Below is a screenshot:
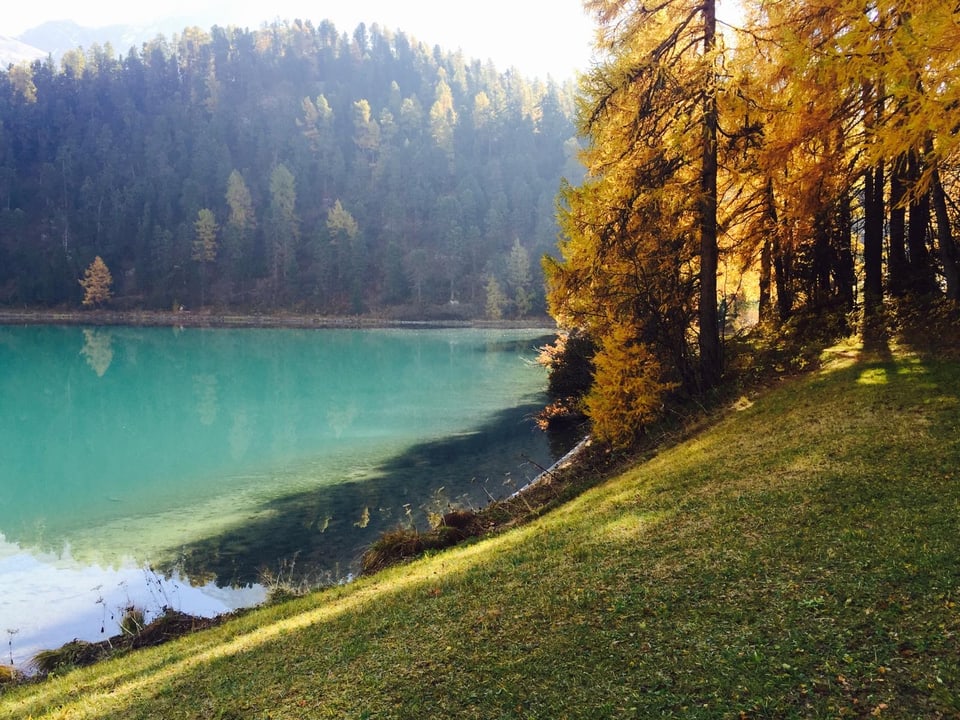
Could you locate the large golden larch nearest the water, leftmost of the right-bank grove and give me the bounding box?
[545,0,722,444]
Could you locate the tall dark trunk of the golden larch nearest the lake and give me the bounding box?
[700,0,722,389]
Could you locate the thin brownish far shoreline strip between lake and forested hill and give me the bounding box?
[0,308,556,331]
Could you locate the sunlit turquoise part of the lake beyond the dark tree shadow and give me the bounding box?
[0,328,556,562]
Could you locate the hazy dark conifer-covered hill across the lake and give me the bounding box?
[0,21,582,317]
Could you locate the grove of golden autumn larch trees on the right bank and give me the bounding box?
[546,0,960,445]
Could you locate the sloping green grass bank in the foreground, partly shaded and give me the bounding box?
[0,340,960,720]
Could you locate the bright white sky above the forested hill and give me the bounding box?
[0,0,593,81]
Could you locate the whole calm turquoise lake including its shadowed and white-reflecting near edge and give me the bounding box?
[0,326,569,665]
